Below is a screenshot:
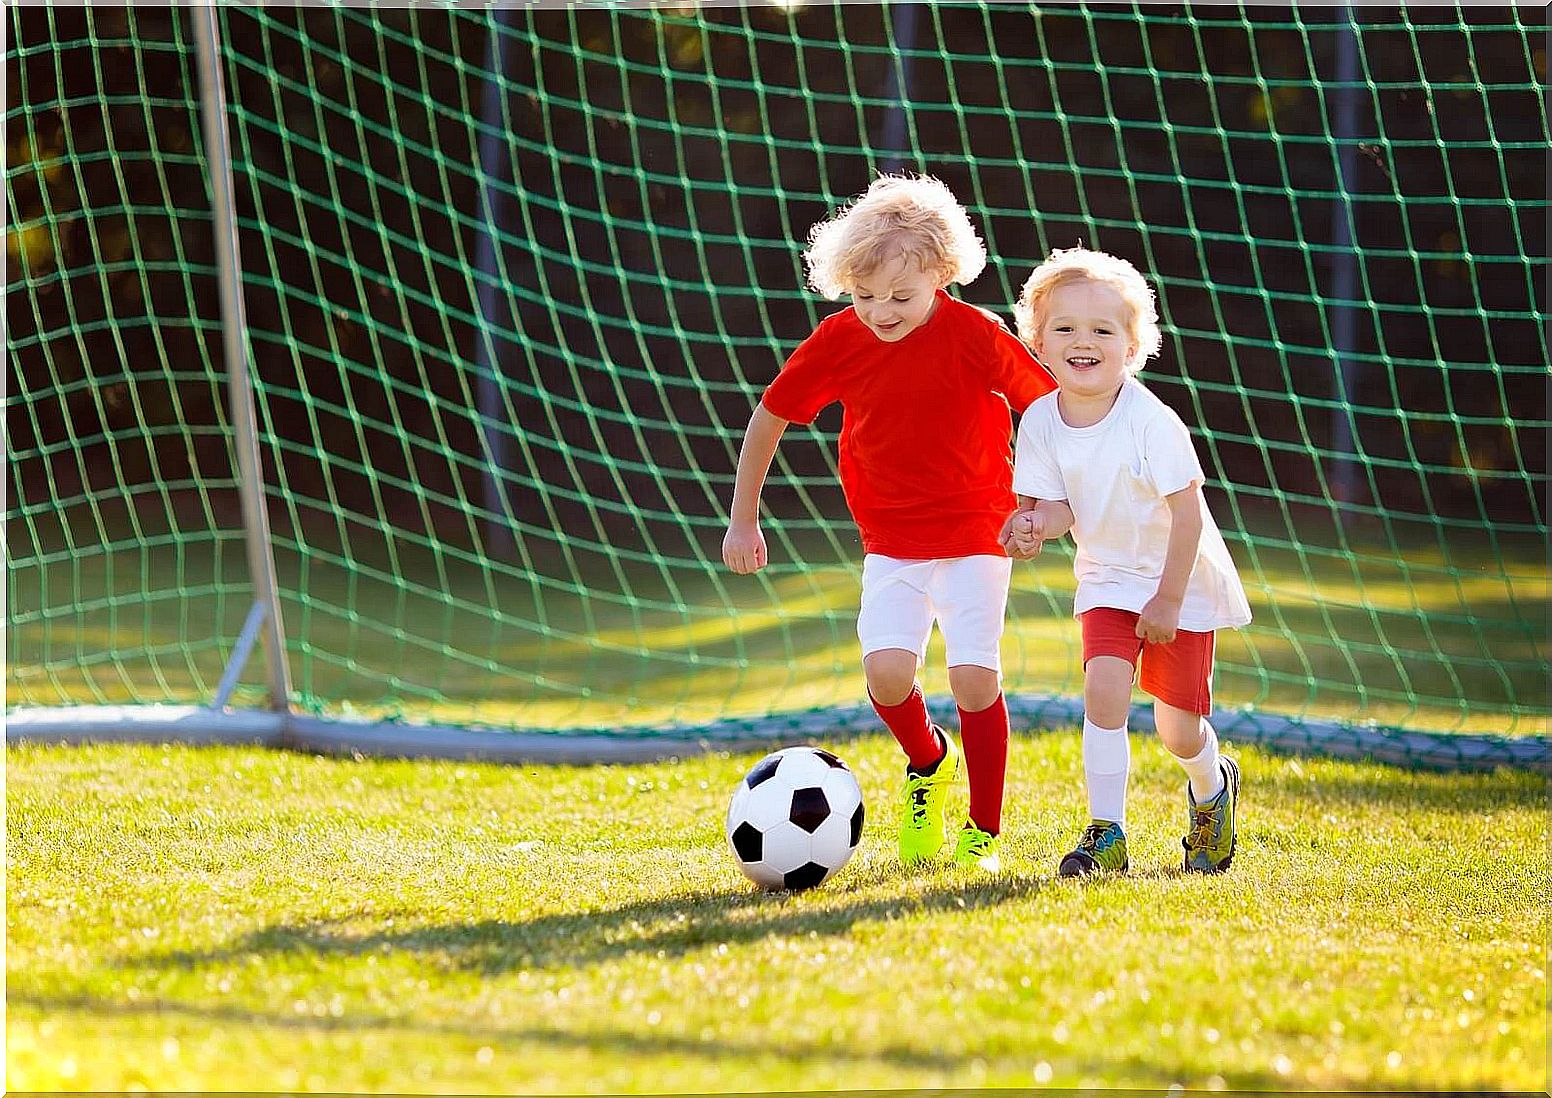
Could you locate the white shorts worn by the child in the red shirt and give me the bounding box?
[857,553,1013,672]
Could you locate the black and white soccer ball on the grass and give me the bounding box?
[728,747,863,891]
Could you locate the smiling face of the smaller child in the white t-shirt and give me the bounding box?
[1034,278,1138,399]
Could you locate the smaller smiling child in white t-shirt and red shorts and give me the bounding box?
[1007,247,1251,876]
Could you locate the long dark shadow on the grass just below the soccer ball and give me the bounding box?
[146,865,1051,975]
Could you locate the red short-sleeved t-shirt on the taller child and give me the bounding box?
[760,290,1057,561]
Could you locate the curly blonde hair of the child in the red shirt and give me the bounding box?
[802,175,986,301]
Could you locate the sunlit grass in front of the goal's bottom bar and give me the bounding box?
[6,733,1549,1093]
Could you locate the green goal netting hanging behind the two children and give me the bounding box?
[6,5,1549,748]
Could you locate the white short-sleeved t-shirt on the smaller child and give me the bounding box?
[1013,379,1251,632]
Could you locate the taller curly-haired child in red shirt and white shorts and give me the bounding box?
[722,175,1055,873]
